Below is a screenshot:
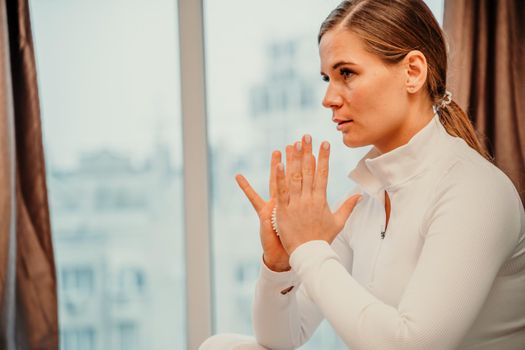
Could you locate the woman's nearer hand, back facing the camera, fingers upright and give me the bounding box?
[274,135,361,255]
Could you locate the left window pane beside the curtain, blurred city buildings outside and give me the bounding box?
[30,0,186,350]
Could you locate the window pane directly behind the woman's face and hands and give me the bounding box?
[204,0,443,349]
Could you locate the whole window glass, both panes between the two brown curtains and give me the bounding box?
[30,0,443,350]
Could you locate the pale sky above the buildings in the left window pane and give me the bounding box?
[31,0,180,166]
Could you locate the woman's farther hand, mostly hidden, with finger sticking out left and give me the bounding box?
[235,146,291,272]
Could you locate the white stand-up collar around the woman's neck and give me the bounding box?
[349,114,452,201]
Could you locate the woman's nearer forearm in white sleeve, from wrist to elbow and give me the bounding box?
[291,241,451,350]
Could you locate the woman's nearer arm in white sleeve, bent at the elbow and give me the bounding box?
[290,165,521,350]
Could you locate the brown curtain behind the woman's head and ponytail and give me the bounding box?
[444,0,525,203]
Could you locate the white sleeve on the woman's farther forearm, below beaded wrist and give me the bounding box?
[253,226,352,349]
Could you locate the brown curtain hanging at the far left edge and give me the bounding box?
[0,0,58,350]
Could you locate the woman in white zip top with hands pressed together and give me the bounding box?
[202,0,525,350]
